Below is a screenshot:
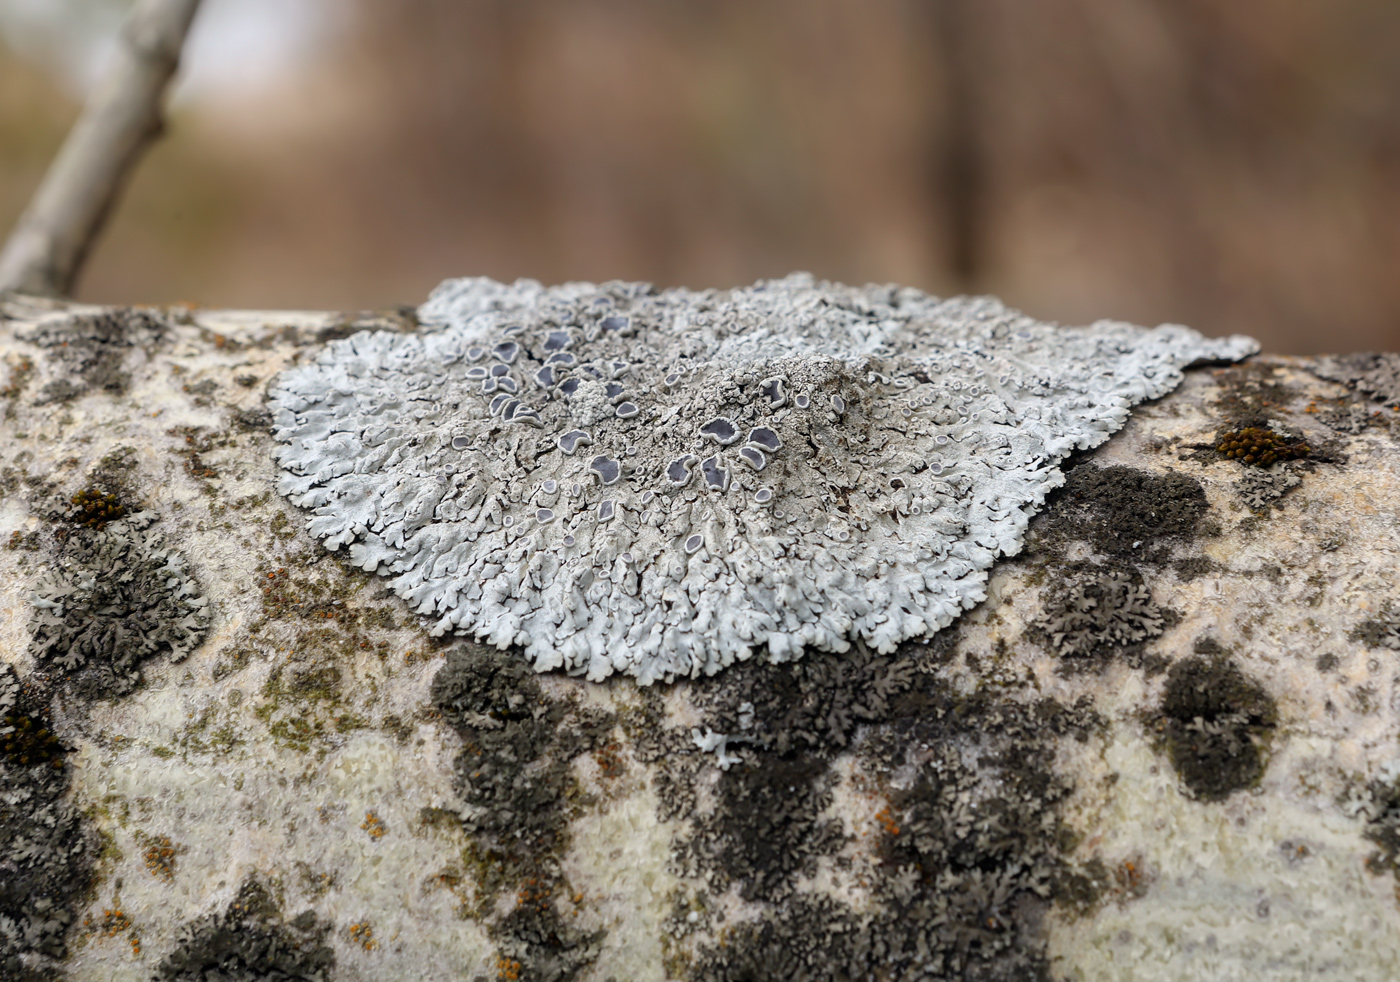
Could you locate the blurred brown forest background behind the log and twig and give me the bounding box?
[0,0,1400,353]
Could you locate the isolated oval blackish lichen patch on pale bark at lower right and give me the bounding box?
[1158,639,1278,801]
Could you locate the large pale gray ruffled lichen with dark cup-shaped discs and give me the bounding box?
[272,276,1257,684]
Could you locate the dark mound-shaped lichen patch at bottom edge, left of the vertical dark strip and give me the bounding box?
[153,880,335,982]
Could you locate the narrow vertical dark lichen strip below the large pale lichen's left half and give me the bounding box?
[433,643,615,982]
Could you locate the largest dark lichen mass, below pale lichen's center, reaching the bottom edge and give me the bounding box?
[658,637,1098,982]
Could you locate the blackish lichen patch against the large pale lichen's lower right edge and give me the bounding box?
[1030,464,1210,563]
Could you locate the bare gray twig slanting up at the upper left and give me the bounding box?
[0,0,199,296]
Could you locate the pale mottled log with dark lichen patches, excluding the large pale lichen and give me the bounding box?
[0,287,1400,982]
